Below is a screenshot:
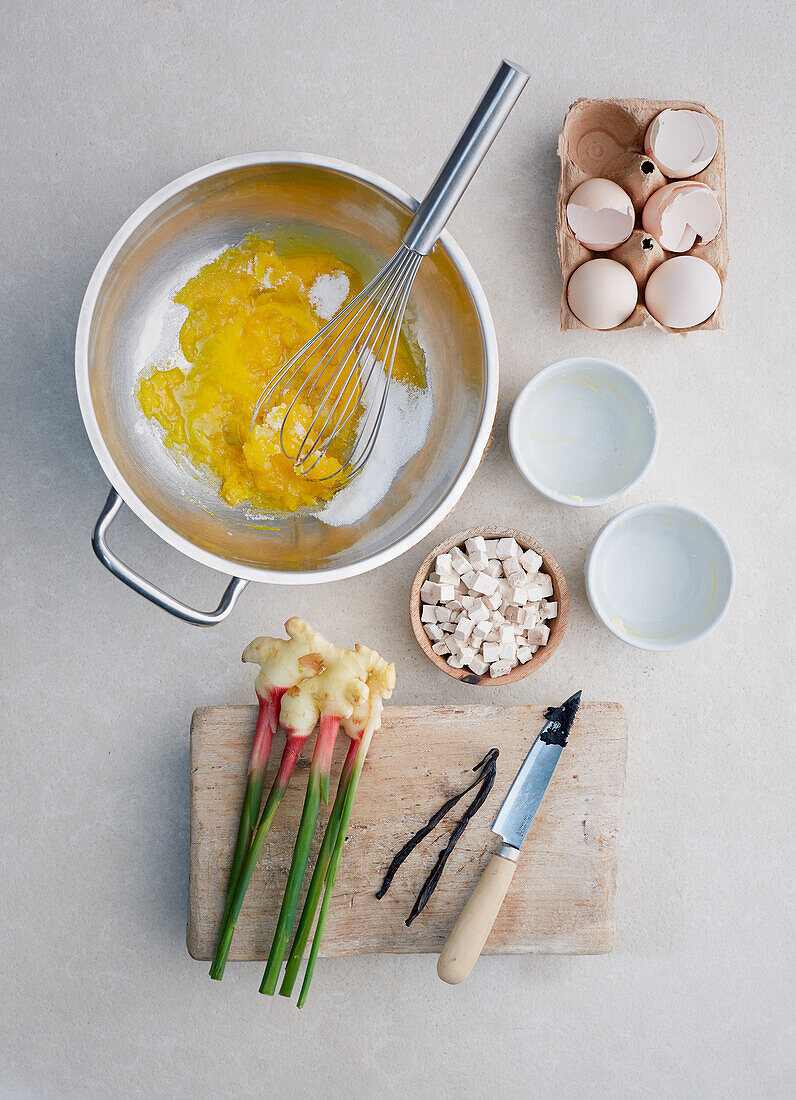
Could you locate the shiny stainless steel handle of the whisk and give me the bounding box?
[401,61,529,256]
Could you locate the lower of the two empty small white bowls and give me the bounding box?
[586,502,734,652]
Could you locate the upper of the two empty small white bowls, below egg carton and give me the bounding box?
[509,358,659,508]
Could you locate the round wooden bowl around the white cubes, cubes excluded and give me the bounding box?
[409,527,570,688]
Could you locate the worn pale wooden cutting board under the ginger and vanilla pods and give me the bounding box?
[188,703,627,959]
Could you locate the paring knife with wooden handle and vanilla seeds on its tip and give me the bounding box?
[436,691,581,986]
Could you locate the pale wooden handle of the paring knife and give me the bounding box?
[436,855,517,986]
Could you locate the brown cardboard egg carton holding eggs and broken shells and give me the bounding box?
[556,99,729,336]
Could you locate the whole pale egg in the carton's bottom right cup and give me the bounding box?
[644,256,721,329]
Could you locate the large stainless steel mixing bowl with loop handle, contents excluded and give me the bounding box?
[75,153,498,626]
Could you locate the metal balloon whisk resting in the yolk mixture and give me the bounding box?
[251,61,529,481]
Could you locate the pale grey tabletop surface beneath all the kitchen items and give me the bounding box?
[0,0,794,1100]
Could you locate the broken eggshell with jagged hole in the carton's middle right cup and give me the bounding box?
[641,180,721,252]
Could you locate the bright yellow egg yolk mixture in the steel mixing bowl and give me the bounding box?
[137,233,425,512]
